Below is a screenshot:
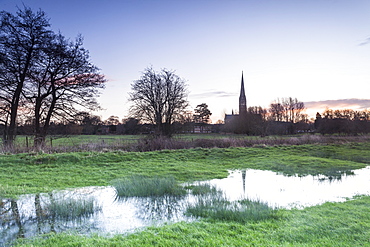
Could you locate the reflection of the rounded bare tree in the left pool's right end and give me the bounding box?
[136,195,186,220]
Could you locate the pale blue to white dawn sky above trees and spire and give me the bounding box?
[0,0,370,123]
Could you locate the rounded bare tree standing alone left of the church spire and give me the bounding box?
[130,68,188,136]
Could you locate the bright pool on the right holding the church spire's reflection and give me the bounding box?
[210,167,370,208]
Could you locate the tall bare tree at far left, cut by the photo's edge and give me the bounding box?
[0,7,52,147]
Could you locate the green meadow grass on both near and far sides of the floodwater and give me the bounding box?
[0,135,370,246]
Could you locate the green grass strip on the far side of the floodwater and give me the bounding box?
[0,142,370,197]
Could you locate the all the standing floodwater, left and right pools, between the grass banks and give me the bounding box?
[0,166,370,246]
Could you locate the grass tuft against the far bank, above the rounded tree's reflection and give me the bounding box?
[112,175,186,198]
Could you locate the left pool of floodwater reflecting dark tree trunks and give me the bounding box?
[0,187,193,246]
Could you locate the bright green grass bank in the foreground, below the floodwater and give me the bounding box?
[18,197,370,246]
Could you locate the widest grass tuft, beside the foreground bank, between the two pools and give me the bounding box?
[186,188,276,223]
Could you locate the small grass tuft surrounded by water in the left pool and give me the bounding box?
[47,197,101,220]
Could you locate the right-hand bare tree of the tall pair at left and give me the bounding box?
[23,34,105,147]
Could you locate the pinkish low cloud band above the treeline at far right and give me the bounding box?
[304,99,370,110]
